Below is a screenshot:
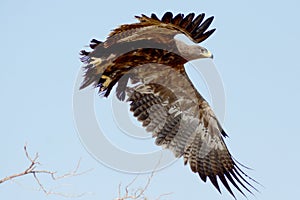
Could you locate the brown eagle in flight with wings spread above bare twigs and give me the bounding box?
[80,12,257,198]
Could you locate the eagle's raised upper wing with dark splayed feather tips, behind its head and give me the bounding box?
[105,12,215,46]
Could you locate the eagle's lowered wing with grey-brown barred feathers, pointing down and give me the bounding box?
[127,64,256,196]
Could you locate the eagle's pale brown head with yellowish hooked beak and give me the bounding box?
[175,39,213,61]
